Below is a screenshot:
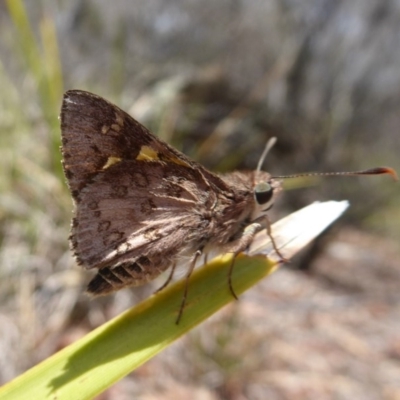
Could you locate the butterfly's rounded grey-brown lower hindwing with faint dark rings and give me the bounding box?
[72,160,214,268]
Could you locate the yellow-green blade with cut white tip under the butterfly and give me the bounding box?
[0,202,347,400]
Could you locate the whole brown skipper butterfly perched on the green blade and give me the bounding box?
[61,90,395,321]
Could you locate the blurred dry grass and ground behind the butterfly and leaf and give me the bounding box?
[0,0,400,400]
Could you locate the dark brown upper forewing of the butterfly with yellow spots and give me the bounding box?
[60,90,198,200]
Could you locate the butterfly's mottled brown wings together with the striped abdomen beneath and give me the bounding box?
[61,90,233,294]
